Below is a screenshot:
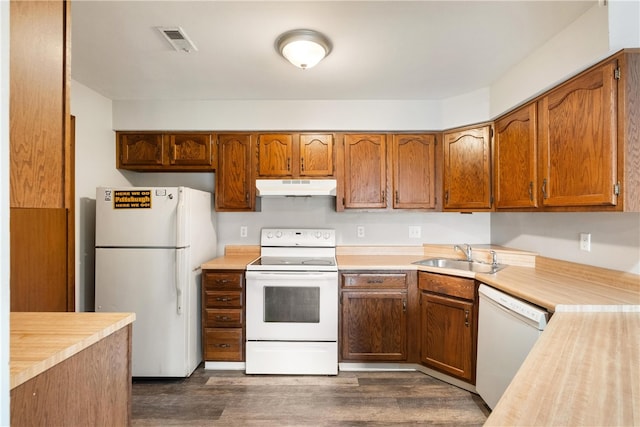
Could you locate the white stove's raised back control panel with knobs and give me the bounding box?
[260,228,336,247]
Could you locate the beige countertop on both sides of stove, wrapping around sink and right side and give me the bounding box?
[202,245,640,425]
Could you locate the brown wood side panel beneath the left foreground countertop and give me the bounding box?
[10,325,131,426]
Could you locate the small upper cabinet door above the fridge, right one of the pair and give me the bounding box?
[168,133,213,167]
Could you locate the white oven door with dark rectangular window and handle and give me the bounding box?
[246,271,338,341]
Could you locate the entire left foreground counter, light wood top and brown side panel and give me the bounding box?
[9,312,135,426]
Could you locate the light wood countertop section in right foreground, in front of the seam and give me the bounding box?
[485,312,640,426]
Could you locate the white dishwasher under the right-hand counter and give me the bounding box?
[476,285,548,409]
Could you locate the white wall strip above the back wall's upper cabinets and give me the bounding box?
[113,100,442,131]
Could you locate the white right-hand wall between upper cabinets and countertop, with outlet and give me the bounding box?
[491,212,640,274]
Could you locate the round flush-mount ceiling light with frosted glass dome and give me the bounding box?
[276,30,331,70]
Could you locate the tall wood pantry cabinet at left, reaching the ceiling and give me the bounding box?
[9,0,75,311]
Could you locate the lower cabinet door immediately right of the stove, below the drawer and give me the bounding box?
[341,291,407,361]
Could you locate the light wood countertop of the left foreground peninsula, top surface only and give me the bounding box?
[9,312,136,389]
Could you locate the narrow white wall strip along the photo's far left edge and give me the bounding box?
[0,1,10,426]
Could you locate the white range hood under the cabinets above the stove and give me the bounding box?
[256,179,336,197]
